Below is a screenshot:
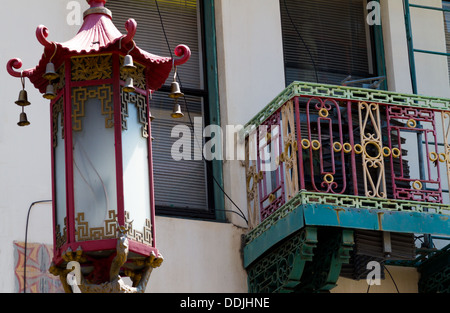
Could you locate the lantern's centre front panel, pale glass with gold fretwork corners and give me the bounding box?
[72,85,117,232]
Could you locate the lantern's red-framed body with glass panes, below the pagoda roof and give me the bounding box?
[51,53,158,283]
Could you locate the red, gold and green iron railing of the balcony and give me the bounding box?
[242,82,450,234]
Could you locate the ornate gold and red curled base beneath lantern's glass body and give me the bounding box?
[49,234,164,293]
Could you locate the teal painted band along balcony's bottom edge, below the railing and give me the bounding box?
[244,197,450,267]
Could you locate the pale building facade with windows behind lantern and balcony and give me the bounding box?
[0,0,450,293]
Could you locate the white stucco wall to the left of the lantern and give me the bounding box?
[0,0,87,292]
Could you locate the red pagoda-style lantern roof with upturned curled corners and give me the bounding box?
[7,0,191,93]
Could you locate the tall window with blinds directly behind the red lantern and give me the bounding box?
[107,0,219,218]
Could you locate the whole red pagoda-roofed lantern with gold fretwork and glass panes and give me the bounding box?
[7,0,190,292]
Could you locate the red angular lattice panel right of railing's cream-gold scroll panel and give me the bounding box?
[386,106,446,203]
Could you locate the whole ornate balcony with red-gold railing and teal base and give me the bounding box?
[242,82,450,292]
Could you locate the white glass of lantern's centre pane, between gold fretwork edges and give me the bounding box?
[73,87,117,228]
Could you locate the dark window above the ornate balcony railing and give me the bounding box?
[280,0,384,87]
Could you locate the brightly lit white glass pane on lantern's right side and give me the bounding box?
[122,94,151,236]
